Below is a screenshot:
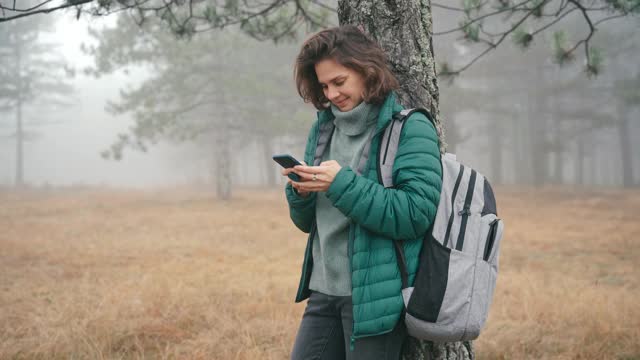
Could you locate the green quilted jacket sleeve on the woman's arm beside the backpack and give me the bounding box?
[326,113,442,240]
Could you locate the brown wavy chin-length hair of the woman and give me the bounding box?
[293,25,399,110]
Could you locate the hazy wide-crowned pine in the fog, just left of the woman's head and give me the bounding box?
[86,16,306,199]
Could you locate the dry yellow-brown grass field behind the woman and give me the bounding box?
[0,188,640,360]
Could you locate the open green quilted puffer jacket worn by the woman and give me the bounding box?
[286,93,442,344]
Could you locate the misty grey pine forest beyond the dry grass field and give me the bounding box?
[0,2,640,196]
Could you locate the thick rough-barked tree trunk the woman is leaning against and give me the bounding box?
[338,0,474,360]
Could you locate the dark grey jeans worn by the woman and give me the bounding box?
[291,291,407,360]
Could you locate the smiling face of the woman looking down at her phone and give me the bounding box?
[315,58,365,112]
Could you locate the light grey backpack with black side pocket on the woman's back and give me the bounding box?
[378,109,504,342]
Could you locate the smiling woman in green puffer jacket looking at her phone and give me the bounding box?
[282,26,441,360]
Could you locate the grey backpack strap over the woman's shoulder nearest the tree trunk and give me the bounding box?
[378,108,436,188]
